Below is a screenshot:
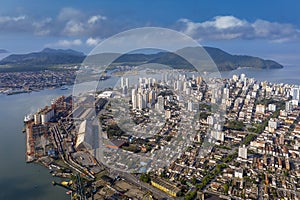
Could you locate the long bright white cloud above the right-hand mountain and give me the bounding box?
[178,16,300,42]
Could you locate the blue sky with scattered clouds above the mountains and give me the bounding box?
[0,0,300,65]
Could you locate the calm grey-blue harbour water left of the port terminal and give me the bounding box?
[0,90,71,200]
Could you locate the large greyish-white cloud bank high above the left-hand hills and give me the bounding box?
[0,7,110,38]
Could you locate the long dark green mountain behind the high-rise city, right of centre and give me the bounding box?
[110,47,283,71]
